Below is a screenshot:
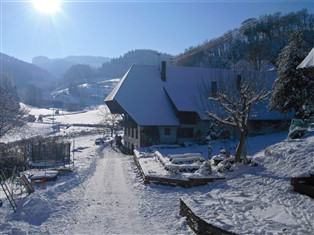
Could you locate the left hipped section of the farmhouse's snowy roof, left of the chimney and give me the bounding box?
[105,65,180,126]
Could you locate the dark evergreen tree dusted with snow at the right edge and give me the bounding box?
[269,33,314,118]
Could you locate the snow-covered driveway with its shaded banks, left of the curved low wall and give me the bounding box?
[0,139,194,235]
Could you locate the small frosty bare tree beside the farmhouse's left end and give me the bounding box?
[99,106,122,137]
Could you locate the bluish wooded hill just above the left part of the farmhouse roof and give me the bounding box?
[99,49,173,78]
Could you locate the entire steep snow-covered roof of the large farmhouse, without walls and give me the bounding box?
[105,65,281,126]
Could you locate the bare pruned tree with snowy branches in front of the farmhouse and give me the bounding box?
[206,71,270,162]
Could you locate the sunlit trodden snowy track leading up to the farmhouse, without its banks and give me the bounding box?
[73,148,160,234]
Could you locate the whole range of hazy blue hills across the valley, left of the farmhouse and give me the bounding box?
[1,49,172,108]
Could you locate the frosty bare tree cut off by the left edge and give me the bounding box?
[0,74,28,139]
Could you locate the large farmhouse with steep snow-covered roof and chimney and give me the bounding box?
[105,62,282,150]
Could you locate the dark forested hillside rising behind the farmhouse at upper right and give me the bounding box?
[173,10,314,70]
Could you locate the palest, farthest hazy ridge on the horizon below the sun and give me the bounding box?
[32,56,111,77]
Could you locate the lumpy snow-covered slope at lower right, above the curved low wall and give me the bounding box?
[183,132,314,234]
